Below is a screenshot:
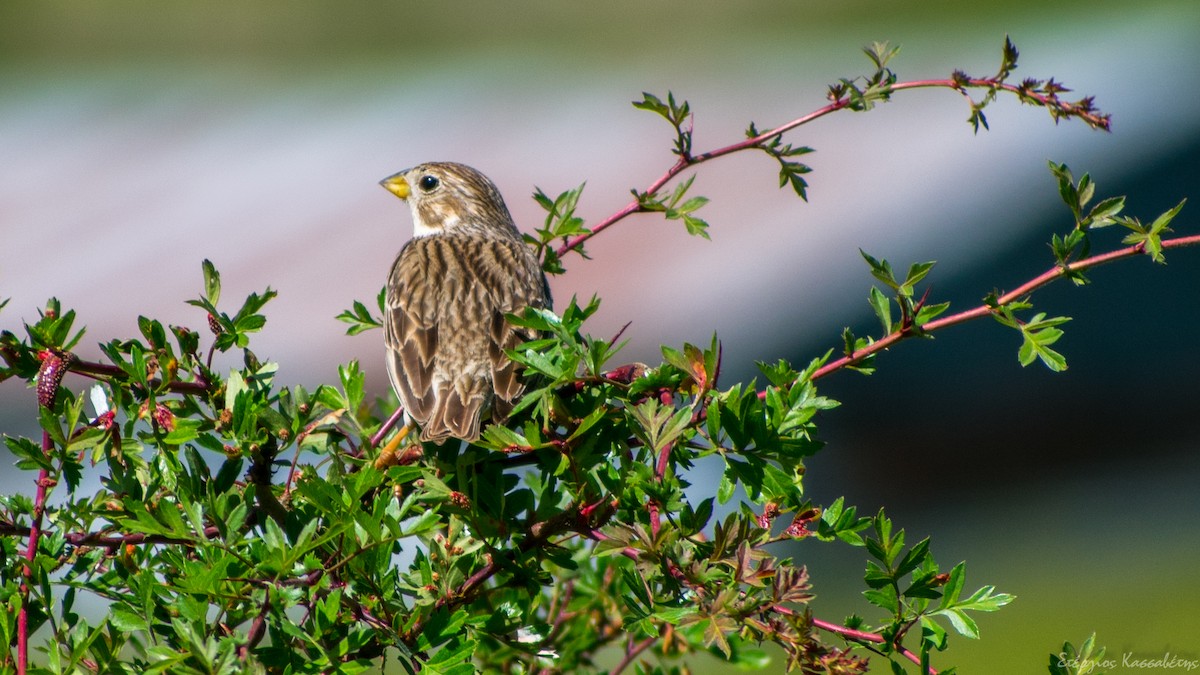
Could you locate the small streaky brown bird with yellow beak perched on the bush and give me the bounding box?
[379,162,551,443]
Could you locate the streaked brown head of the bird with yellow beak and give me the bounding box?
[379,162,516,237]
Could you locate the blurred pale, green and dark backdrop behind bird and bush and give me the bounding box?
[0,0,1200,673]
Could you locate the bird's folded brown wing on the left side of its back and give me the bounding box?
[384,238,439,425]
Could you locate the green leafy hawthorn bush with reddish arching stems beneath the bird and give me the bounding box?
[0,42,1200,674]
